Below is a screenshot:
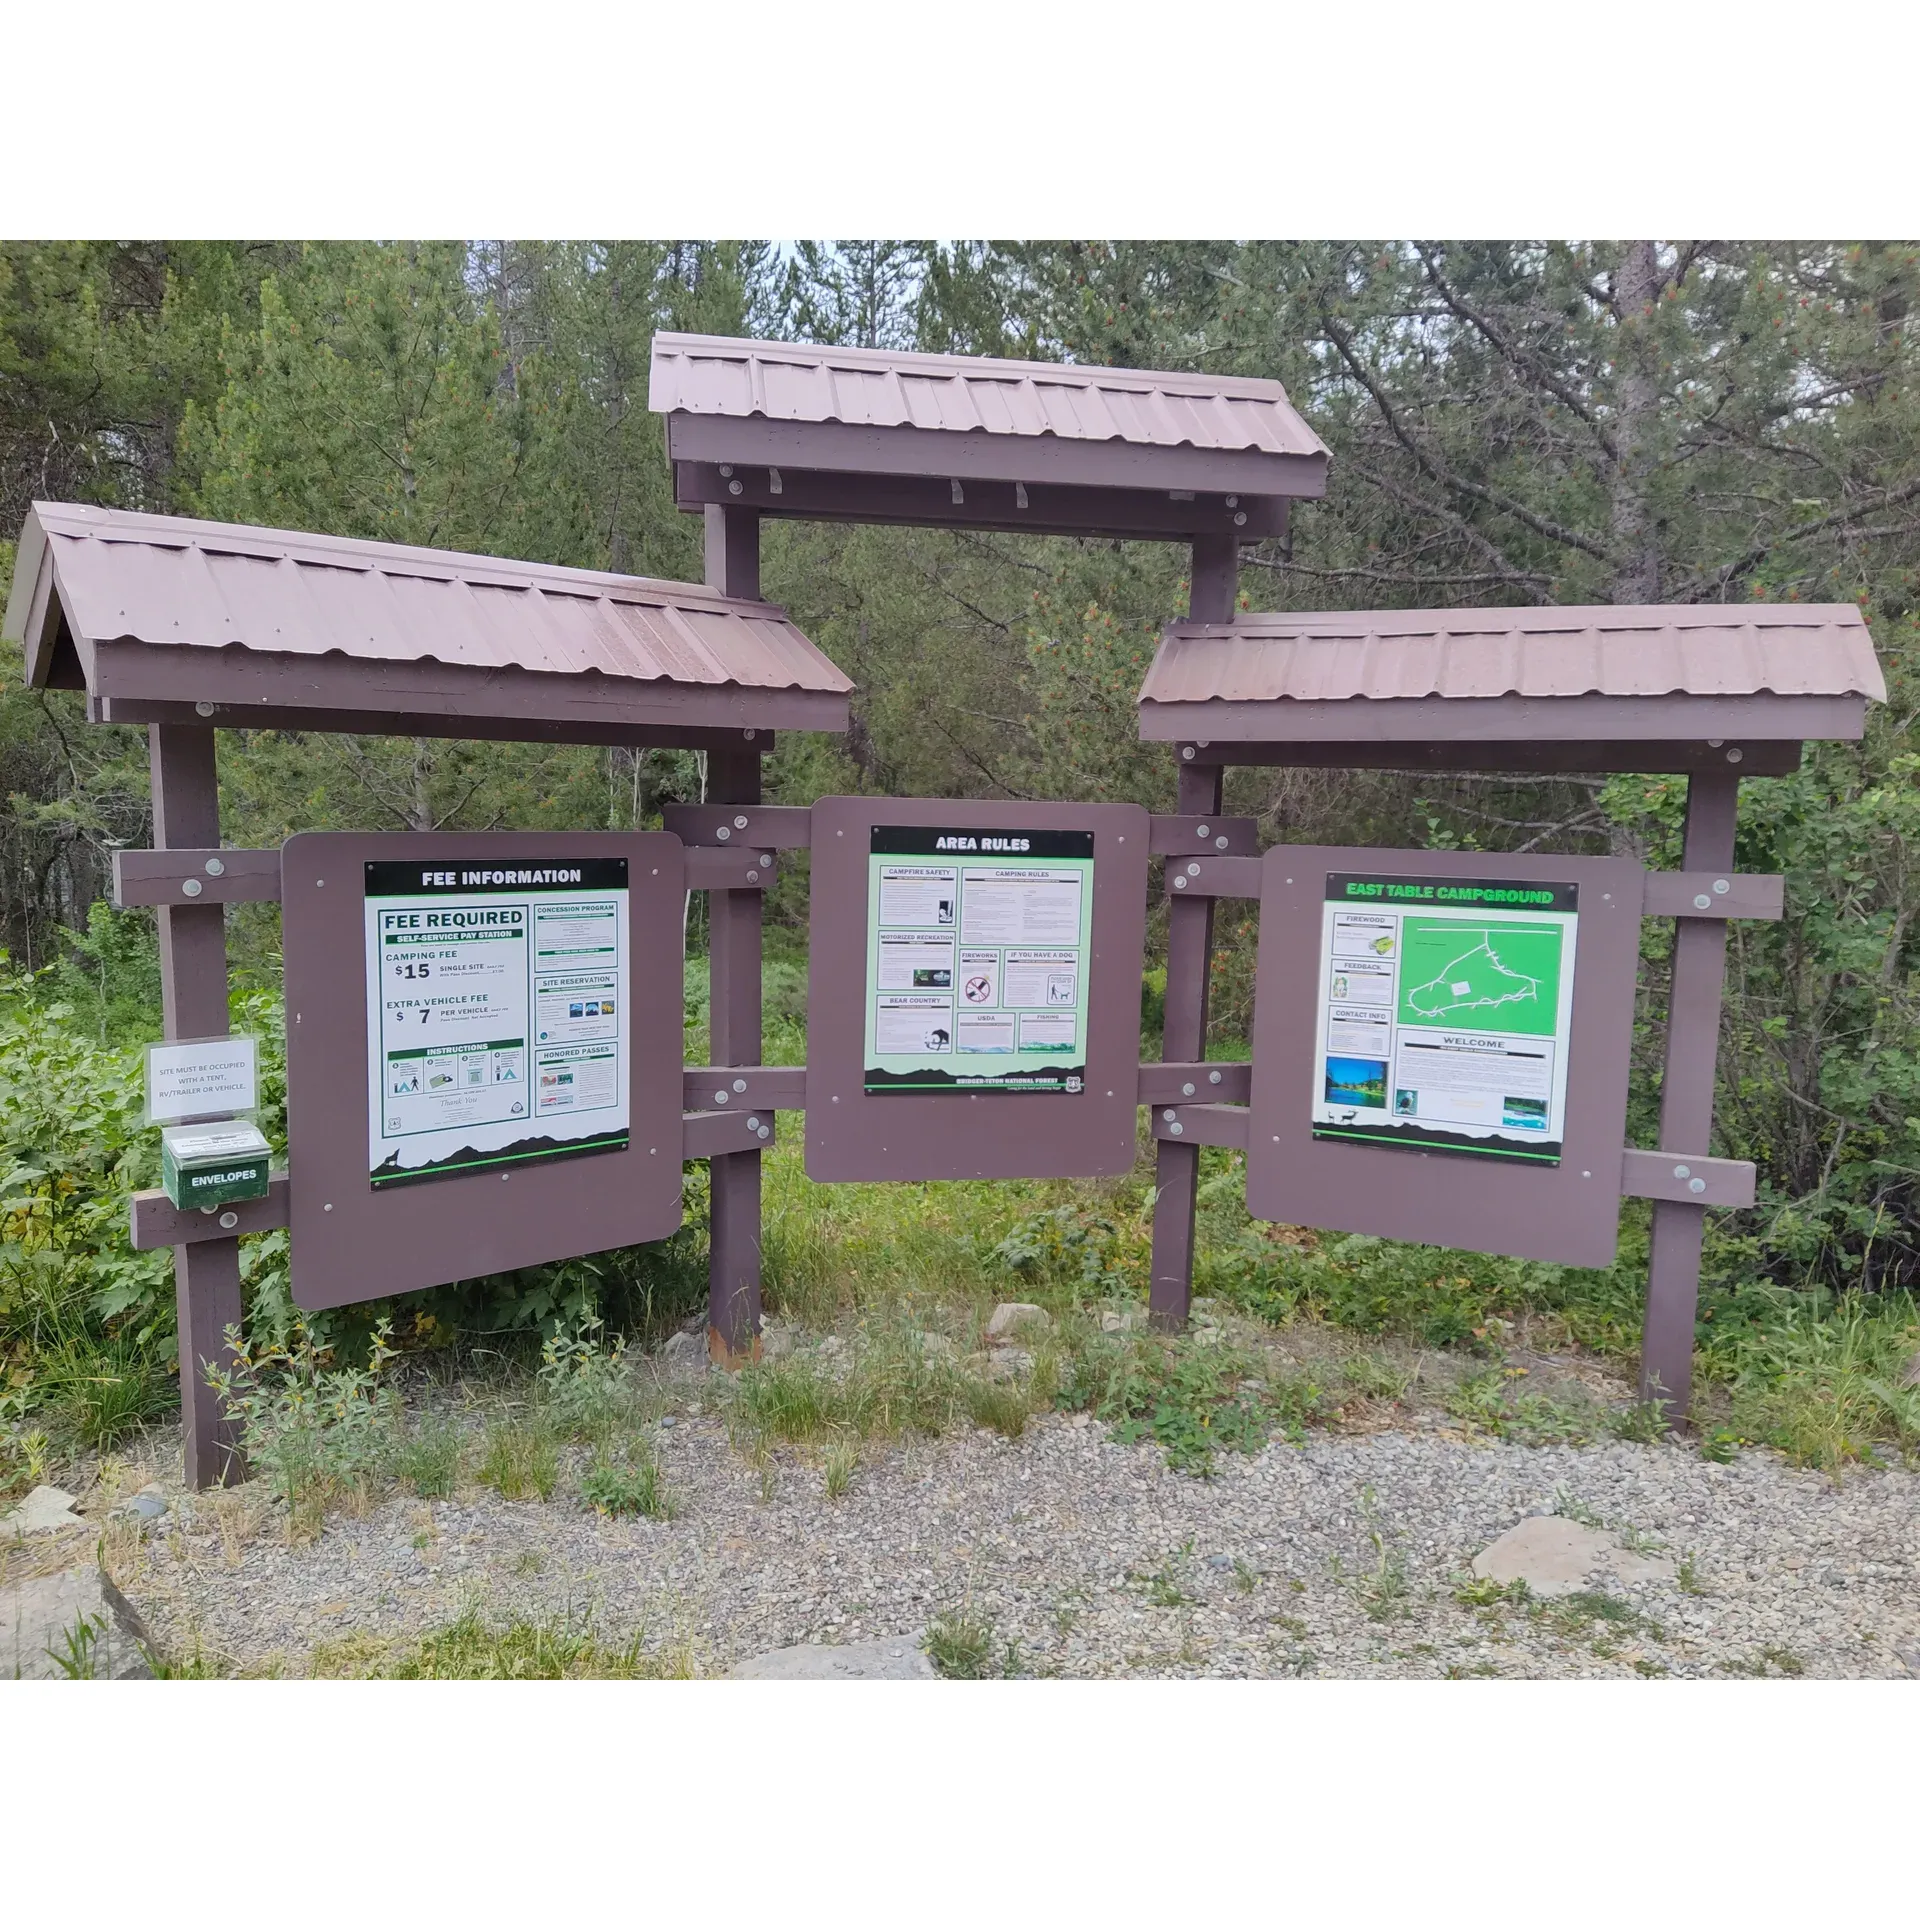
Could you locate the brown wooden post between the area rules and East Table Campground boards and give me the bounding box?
[1146,534,1240,1329]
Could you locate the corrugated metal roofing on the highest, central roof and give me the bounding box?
[647,334,1327,457]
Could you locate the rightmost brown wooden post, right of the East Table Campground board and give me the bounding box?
[1640,770,1740,1423]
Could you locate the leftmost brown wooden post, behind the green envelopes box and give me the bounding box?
[146,726,244,1486]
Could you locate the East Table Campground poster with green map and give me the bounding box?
[1313,874,1580,1167]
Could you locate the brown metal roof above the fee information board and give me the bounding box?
[6,503,852,728]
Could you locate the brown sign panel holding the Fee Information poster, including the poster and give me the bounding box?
[282,833,685,1308]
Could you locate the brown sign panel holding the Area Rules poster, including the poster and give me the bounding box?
[806,799,1148,1181]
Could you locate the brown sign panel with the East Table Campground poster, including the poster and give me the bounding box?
[1246,847,1644,1267]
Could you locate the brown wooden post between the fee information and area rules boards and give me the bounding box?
[707,507,762,1369]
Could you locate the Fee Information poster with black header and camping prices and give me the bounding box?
[367,858,630,1188]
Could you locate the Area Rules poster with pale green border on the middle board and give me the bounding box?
[864,828,1092,1094]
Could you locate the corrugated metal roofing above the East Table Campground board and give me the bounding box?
[1140,603,1887,707]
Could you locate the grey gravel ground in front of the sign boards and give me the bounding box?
[109,1413,1920,1678]
